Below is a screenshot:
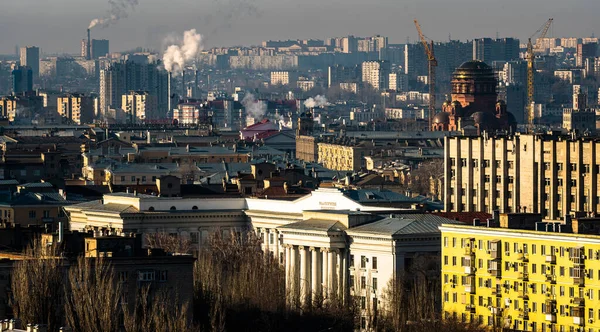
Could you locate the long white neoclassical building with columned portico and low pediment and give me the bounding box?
[65,188,457,328]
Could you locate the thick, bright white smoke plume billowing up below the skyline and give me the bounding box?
[163,29,202,74]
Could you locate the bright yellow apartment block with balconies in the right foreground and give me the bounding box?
[440,213,600,331]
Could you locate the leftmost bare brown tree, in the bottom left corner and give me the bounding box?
[11,239,65,331]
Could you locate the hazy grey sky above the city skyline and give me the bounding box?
[0,0,600,54]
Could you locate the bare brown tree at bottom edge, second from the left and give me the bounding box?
[65,256,121,332]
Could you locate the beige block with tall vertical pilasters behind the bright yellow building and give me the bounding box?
[443,133,600,220]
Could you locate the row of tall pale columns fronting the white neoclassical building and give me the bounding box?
[284,244,348,307]
